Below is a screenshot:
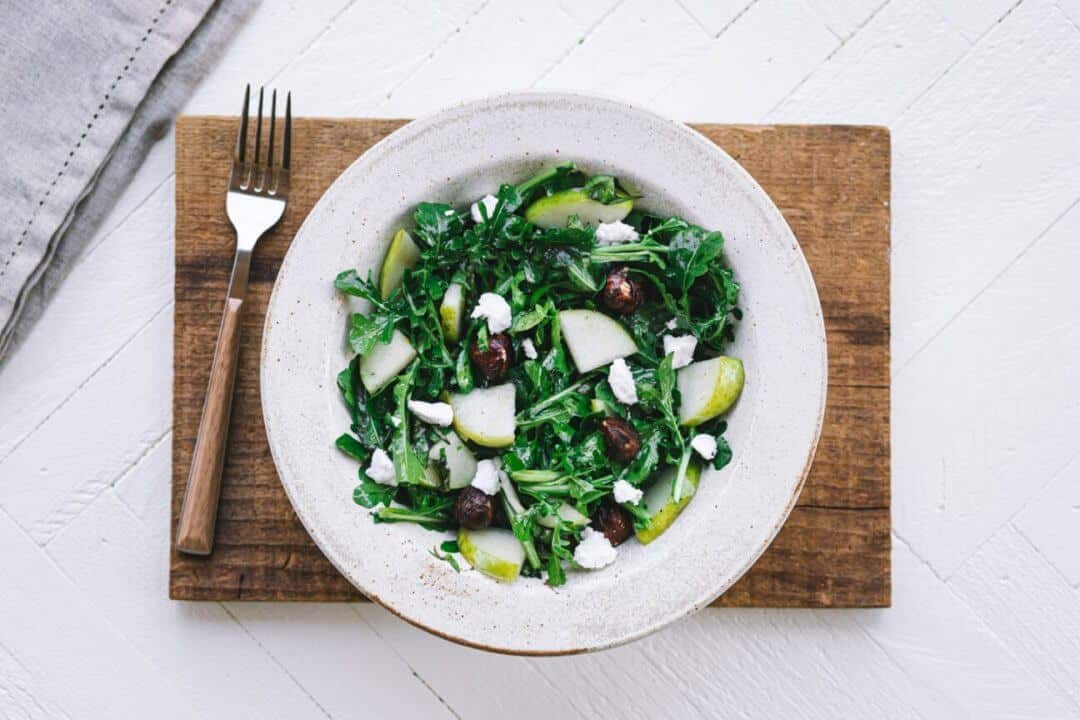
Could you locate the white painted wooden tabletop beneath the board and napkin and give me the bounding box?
[0,0,1080,720]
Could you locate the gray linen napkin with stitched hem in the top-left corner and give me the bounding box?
[0,0,257,361]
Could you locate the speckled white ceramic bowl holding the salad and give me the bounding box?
[261,93,826,654]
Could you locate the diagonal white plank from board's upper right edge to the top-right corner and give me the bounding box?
[893,0,1080,367]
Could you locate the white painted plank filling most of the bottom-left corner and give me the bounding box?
[0,512,191,720]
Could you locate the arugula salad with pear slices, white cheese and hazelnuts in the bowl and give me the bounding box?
[334,163,744,586]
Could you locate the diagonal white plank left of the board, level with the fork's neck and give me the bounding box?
[0,181,174,462]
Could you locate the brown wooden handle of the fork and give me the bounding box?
[176,297,244,555]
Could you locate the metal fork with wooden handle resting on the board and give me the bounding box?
[176,85,293,555]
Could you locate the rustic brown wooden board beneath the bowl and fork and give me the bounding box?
[168,117,891,608]
